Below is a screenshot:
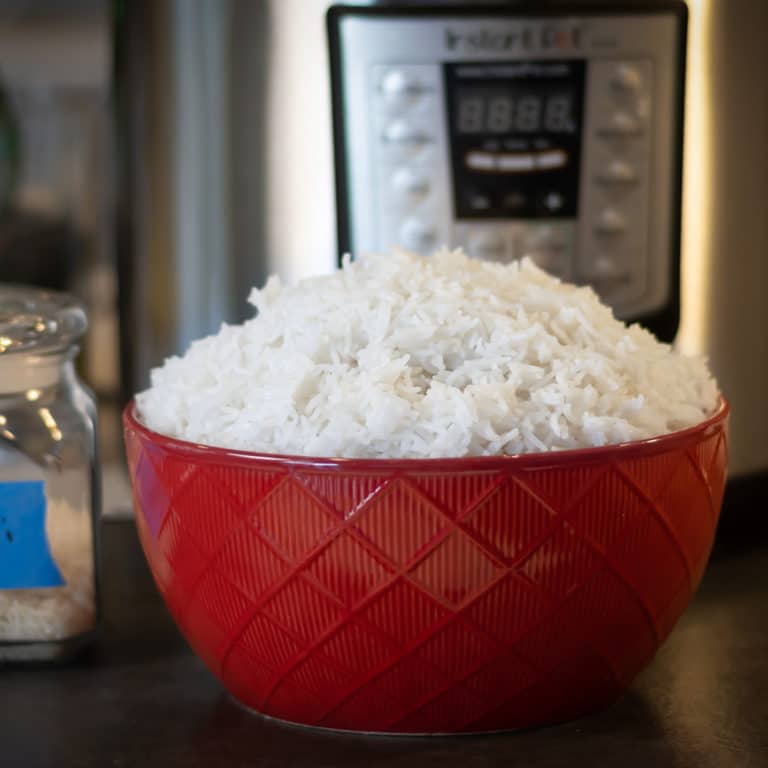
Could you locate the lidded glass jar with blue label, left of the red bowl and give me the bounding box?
[0,285,100,661]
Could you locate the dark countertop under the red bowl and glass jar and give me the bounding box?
[0,522,768,768]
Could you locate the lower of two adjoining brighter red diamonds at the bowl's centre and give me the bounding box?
[409,530,501,606]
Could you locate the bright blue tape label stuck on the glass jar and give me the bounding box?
[0,480,64,589]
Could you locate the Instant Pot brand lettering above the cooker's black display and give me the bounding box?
[445,24,582,52]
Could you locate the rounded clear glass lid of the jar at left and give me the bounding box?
[0,285,88,360]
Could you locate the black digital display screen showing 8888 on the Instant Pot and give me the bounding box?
[443,60,585,219]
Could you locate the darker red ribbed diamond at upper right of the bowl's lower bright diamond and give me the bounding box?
[465,479,556,561]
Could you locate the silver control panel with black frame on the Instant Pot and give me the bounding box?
[328,2,686,341]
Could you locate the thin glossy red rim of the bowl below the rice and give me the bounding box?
[123,395,730,473]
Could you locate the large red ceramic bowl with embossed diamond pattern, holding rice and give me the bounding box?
[124,403,728,733]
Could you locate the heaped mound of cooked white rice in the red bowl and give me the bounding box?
[137,250,718,457]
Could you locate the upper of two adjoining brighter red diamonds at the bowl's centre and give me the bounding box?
[355,482,448,566]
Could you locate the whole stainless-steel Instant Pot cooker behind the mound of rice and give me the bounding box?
[116,0,768,498]
